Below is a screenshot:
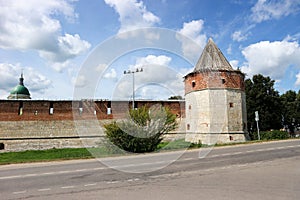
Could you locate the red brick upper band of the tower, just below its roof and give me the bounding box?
[185,71,245,94]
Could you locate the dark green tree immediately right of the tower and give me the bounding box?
[245,74,282,132]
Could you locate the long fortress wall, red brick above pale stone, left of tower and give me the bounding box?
[0,99,185,151]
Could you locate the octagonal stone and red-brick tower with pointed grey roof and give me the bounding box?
[184,38,248,144]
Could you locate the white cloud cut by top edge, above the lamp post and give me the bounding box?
[104,0,160,33]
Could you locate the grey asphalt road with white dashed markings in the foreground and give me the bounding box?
[0,140,300,200]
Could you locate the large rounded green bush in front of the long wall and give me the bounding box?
[104,106,177,153]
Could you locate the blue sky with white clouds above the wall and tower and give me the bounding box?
[0,0,300,100]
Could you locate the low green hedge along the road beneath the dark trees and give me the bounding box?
[250,130,289,140]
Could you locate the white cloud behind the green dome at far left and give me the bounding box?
[0,63,52,98]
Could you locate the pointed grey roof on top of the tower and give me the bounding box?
[194,38,234,72]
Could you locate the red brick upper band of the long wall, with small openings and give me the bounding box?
[0,100,185,121]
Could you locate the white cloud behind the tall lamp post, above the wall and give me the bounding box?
[113,55,184,100]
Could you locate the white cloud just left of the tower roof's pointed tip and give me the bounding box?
[176,19,207,60]
